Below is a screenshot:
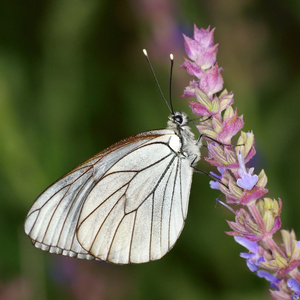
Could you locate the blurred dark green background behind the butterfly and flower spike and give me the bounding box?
[0,0,300,300]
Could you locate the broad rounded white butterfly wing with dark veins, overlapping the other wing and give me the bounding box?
[77,133,192,264]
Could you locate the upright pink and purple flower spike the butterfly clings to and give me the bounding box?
[182,25,300,300]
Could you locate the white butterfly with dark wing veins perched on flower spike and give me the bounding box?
[24,51,201,264]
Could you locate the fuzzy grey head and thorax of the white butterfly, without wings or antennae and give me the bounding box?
[168,112,201,165]
